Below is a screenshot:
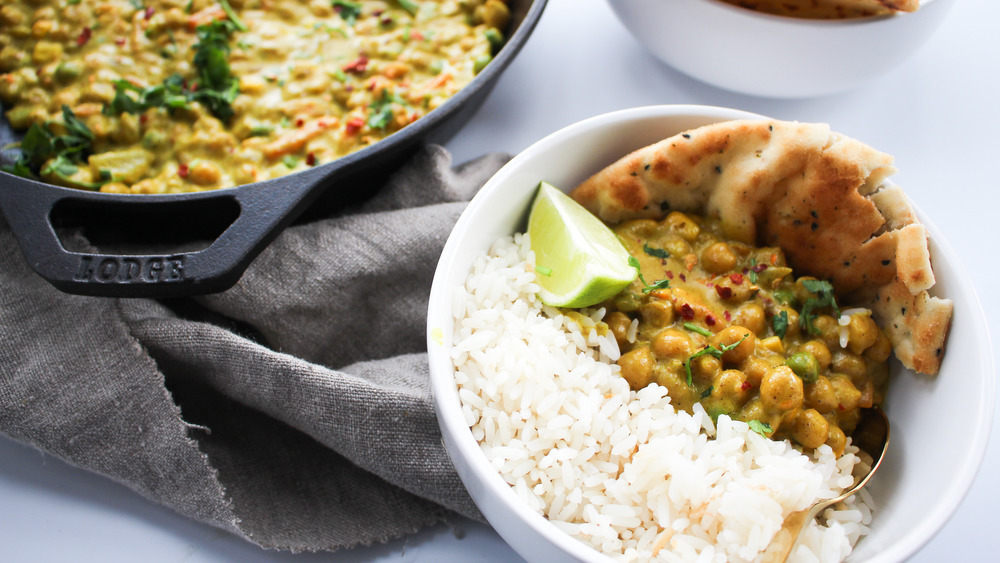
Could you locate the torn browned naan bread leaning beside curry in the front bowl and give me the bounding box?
[571,120,952,374]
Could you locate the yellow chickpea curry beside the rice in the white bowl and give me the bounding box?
[604,212,891,455]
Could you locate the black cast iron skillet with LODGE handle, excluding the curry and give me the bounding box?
[0,0,547,297]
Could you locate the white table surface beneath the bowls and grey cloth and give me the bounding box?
[0,0,1000,562]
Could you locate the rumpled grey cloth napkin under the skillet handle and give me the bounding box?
[0,146,508,552]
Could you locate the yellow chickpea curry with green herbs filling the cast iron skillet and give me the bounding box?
[0,0,510,193]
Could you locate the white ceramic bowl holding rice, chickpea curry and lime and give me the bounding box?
[427,106,994,563]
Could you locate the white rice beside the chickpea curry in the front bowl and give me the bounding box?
[452,231,872,562]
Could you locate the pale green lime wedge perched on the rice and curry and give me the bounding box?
[528,182,638,308]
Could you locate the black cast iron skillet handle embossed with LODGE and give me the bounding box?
[0,168,330,298]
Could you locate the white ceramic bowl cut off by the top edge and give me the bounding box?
[608,0,953,98]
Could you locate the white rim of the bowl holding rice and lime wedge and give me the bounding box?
[427,104,995,562]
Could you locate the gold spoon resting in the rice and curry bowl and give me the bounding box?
[763,407,889,563]
